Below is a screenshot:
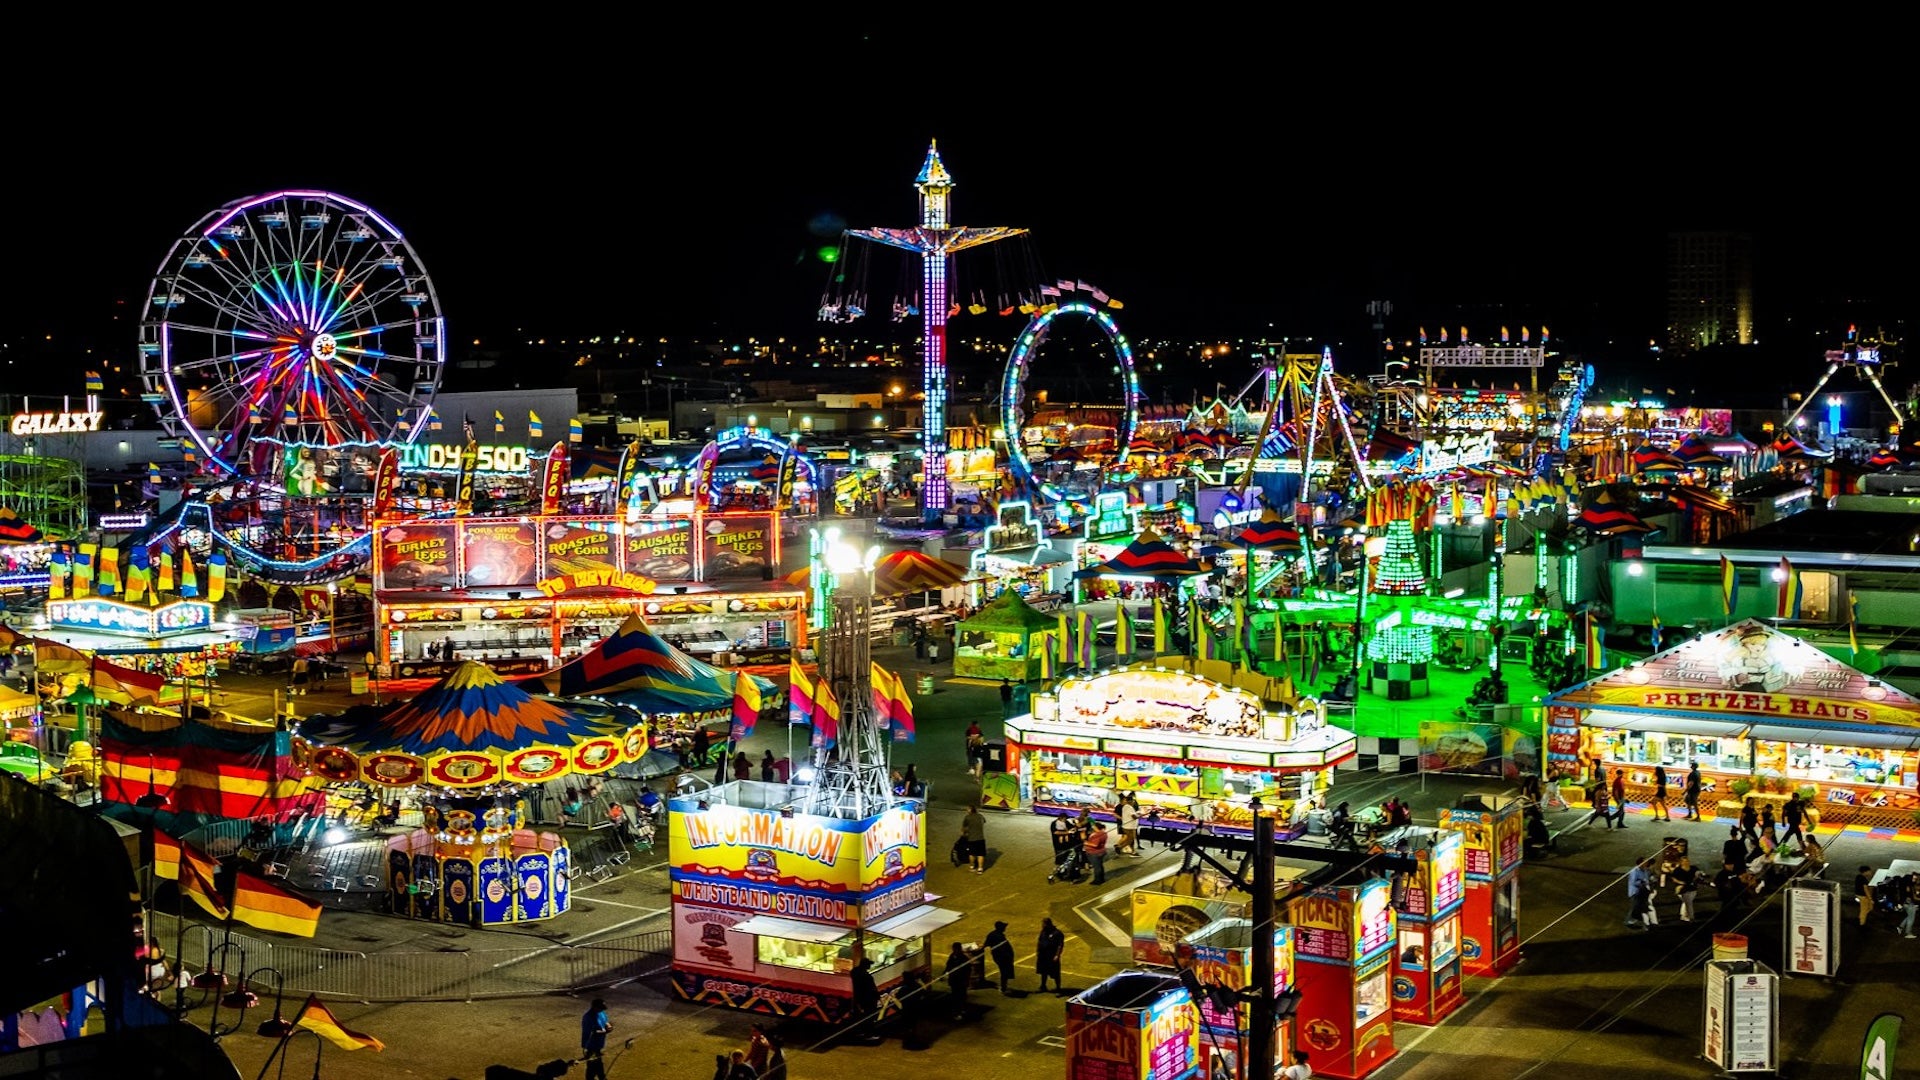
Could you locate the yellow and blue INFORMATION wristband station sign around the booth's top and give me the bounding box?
[668,799,927,926]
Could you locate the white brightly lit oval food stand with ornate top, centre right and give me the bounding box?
[1002,663,1356,826]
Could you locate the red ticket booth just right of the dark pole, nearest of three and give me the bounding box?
[1281,878,1396,1080]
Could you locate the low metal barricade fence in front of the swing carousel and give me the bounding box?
[154,913,672,1007]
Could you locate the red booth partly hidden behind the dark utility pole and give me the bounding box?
[1175,919,1296,1080]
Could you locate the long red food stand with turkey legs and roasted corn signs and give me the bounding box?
[372,511,806,678]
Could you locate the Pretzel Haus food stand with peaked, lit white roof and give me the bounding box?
[1548,619,1920,828]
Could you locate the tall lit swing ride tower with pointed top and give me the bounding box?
[847,142,1025,521]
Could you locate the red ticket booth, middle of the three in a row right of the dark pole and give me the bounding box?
[1394,826,1467,1024]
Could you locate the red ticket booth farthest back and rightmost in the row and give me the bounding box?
[1440,796,1524,974]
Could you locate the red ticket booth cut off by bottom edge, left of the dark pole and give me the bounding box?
[1066,970,1200,1080]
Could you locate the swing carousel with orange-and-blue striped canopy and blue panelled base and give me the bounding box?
[296,661,649,926]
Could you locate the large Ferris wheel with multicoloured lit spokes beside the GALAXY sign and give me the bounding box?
[140,190,445,475]
